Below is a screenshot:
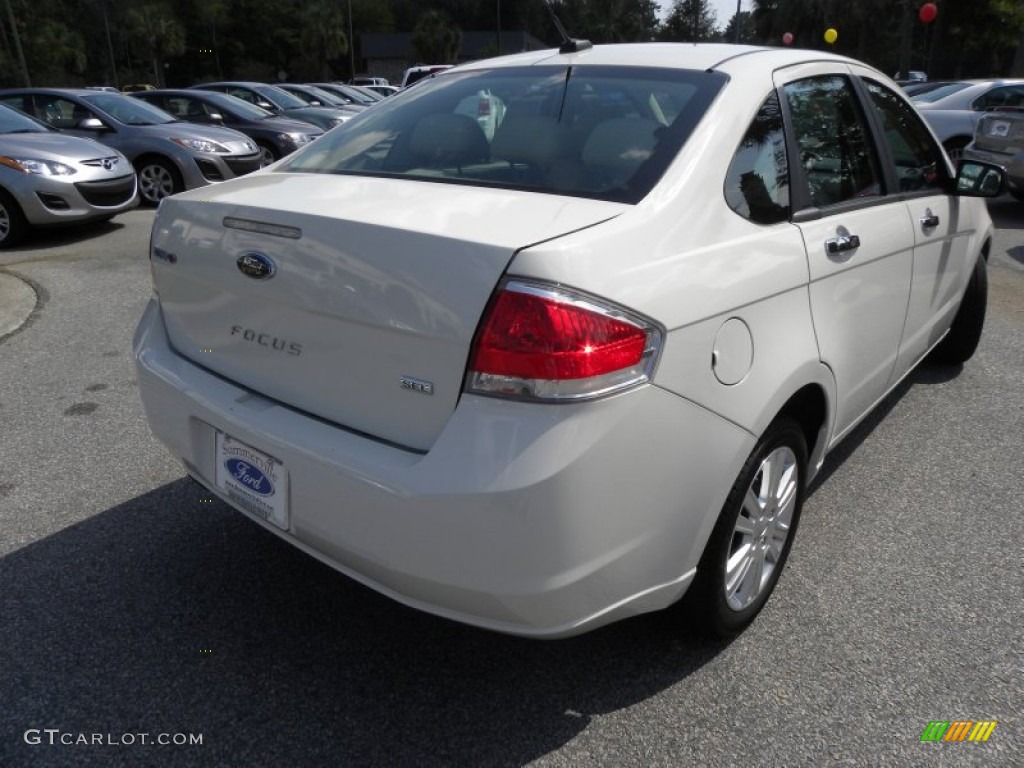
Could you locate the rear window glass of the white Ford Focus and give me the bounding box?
[280,66,726,203]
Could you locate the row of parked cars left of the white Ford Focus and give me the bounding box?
[0,81,403,248]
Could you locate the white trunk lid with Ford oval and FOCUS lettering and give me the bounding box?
[153,173,626,451]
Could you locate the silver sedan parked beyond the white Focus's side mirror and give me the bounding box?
[912,80,1024,162]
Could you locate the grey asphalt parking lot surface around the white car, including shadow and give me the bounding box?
[0,199,1024,768]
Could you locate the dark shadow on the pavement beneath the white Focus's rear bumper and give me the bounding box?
[0,479,725,766]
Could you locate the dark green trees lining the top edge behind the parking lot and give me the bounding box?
[0,0,1024,86]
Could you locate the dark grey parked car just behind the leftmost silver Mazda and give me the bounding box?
[0,88,262,205]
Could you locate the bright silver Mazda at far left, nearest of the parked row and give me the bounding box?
[0,106,138,248]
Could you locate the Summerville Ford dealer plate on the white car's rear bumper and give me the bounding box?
[214,431,288,530]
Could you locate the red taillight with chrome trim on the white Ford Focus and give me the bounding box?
[467,282,660,399]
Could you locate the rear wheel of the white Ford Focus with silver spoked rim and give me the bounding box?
[683,417,807,638]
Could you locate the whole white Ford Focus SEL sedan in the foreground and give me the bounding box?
[134,44,1005,637]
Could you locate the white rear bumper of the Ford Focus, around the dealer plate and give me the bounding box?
[134,300,754,637]
